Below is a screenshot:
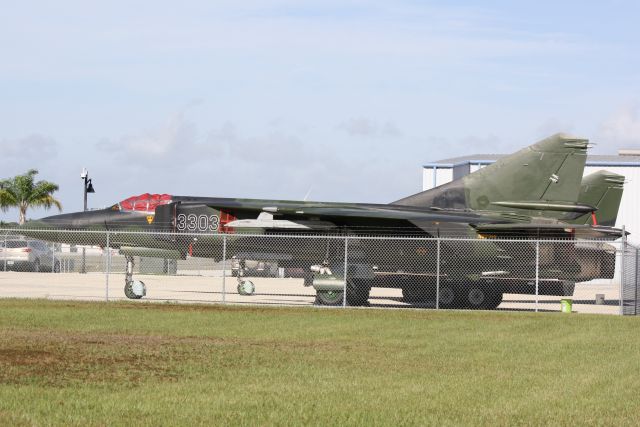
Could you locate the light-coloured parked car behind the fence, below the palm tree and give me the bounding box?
[0,239,60,273]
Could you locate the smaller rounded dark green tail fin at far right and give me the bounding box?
[569,170,624,227]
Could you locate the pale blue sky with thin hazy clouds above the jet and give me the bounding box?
[0,0,640,219]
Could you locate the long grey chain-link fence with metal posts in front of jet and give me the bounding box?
[0,229,640,315]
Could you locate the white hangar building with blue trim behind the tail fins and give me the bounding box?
[422,150,640,244]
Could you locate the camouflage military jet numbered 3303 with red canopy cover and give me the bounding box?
[21,134,623,308]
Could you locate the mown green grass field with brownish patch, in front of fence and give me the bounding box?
[0,300,640,425]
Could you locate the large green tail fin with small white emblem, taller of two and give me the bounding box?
[393,134,588,211]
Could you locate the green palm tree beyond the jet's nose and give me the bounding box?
[0,169,62,225]
